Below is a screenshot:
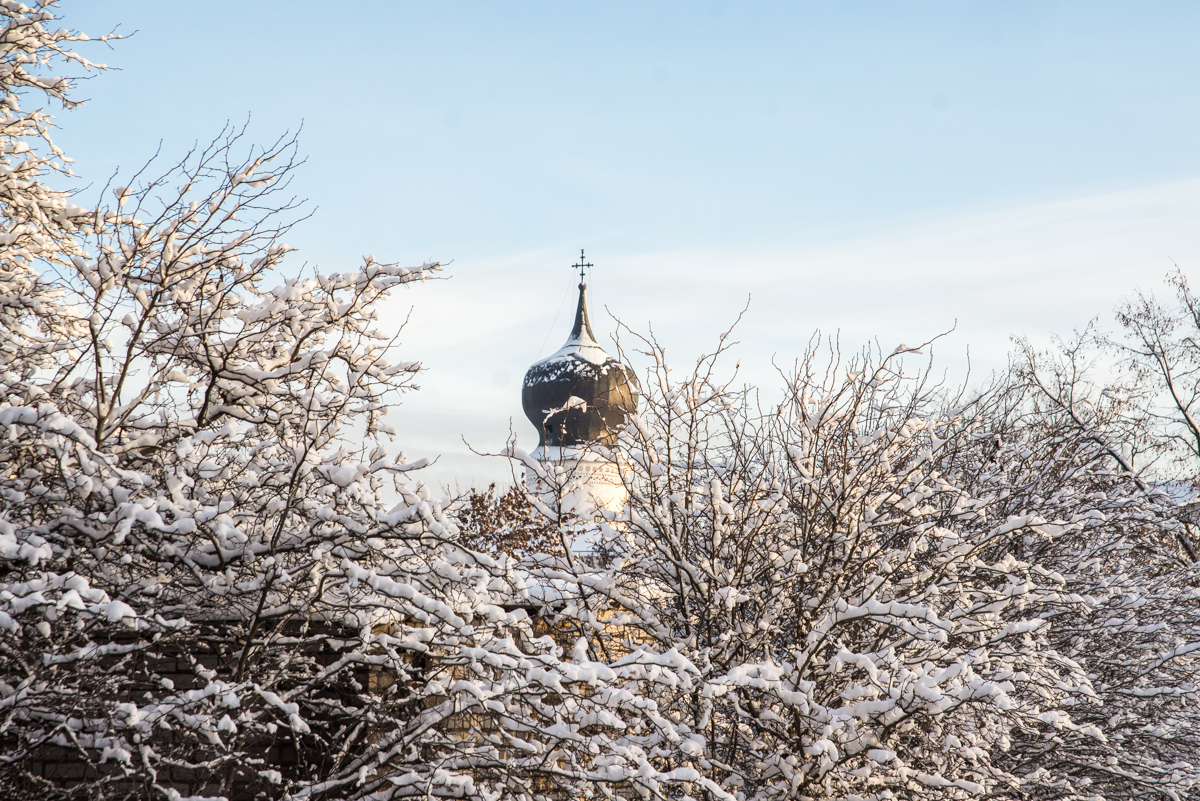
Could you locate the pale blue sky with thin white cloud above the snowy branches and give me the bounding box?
[55,0,1200,487]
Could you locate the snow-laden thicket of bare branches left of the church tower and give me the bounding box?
[0,2,696,799]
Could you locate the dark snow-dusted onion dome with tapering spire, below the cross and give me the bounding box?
[521,282,638,447]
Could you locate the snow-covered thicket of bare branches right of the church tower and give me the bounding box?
[518,317,1200,799]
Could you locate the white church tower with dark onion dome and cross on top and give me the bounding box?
[521,251,638,520]
